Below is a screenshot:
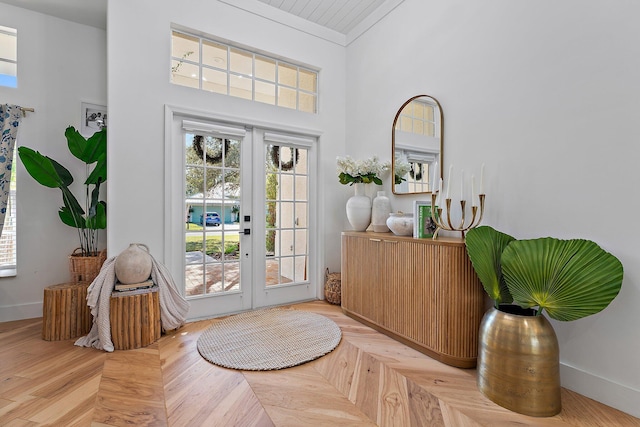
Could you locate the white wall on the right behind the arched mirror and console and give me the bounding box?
[347,0,640,416]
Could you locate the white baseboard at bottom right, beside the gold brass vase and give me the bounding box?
[560,363,640,418]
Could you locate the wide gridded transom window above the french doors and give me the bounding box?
[171,30,318,113]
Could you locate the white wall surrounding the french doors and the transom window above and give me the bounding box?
[107,0,349,288]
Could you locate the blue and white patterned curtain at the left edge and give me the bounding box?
[0,104,22,236]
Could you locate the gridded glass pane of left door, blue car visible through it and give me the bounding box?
[185,134,240,297]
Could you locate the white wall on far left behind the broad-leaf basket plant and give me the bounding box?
[0,4,107,322]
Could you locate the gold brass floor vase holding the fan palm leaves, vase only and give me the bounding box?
[477,305,561,417]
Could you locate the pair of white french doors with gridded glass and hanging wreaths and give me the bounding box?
[165,110,317,319]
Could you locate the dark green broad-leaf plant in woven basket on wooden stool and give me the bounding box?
[18,126,107,282]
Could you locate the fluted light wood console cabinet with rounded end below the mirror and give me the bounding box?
[342,231,485,368]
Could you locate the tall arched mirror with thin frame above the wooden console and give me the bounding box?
[391,95,444,194]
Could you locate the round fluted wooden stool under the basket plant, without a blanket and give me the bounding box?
[42,282,92,341]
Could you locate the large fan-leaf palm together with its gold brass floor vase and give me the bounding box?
[465,226,623,416]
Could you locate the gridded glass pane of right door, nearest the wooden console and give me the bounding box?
[265,144,309,286]
